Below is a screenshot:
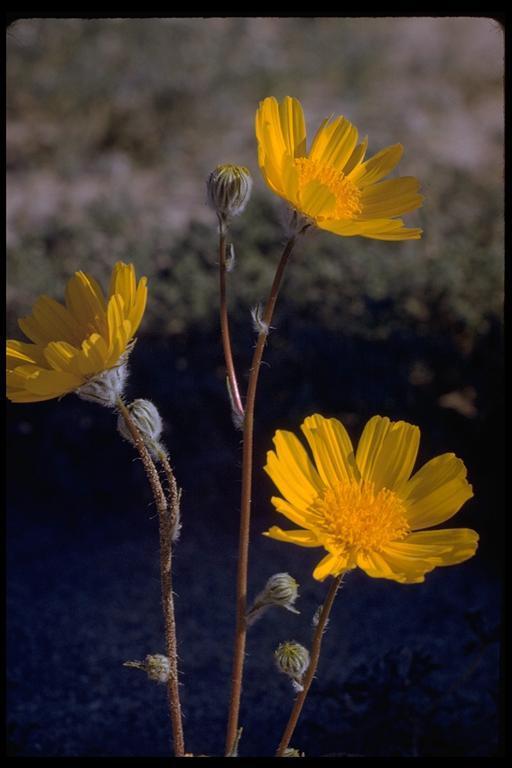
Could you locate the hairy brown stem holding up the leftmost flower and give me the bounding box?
[117,398,185,757]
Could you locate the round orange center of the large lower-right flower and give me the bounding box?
[312,480,410,552]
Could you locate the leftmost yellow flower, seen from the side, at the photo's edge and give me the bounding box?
[7,261,147,403]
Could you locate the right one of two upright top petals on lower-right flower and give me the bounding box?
[356,416,420,492]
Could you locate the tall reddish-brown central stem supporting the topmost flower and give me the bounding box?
[226,236,296,755]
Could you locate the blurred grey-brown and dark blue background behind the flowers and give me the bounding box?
[7,18,504,756]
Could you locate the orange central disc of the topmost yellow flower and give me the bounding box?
[295,157,362,220]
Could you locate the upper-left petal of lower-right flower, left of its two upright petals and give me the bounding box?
[265,430,323,510]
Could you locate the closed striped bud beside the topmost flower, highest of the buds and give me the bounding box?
[206,165,252,222]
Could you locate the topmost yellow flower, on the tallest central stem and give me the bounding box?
[256,96,423,240]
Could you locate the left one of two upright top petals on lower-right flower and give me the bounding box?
[301,413,359,487]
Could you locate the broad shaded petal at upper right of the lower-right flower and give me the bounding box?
[402,453,473,530]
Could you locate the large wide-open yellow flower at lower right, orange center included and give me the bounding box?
[265,414,478,584]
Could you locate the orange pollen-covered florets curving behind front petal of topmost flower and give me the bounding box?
[295,157,362,221]
